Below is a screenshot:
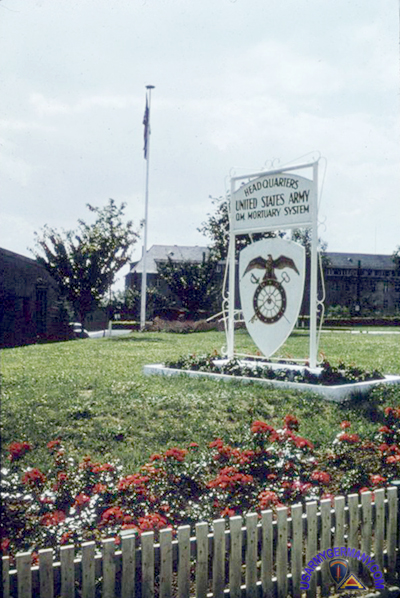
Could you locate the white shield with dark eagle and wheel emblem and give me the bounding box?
[239,239,305,357]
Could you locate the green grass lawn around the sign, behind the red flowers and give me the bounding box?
[1,331,400,472]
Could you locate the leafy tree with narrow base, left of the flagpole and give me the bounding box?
[33,199,139,325]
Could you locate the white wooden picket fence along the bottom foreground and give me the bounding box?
[3,487,400,598]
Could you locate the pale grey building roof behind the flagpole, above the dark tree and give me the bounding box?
[130,245,210,274]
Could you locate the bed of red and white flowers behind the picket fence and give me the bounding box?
[1,408,400,558]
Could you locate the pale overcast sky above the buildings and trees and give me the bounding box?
[0,0,400,290]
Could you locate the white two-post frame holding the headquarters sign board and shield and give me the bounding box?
[226,161,318,368]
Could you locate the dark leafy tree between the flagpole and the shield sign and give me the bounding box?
[157,256,221,316]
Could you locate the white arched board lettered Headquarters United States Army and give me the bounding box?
[231,172,315,234]
